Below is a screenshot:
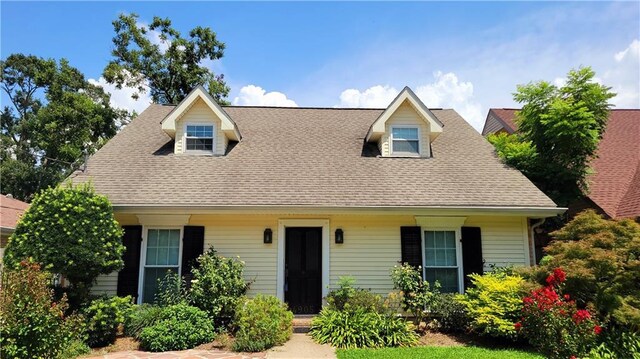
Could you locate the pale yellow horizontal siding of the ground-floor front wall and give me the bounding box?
[94,214,529,295]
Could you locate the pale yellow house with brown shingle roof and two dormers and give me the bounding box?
[67,87,564,313]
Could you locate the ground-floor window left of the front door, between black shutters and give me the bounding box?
[142,229,181,303]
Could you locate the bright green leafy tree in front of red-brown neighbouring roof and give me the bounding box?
[490,67,615,206]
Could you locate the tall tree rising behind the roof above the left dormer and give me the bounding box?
[103,14,229,104]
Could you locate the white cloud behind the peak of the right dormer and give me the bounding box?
[337,71,484,130]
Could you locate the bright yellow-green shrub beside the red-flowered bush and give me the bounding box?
[456,271,524,339]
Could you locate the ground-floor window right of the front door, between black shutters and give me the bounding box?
[424,231,459,293]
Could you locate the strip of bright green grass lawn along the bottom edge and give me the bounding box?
[337,347,544,359]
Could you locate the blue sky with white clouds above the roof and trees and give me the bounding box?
[0,1,640,130]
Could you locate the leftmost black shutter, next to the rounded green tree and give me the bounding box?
[117,226,142,301]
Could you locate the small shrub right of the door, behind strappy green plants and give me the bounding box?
[327,276,388,313]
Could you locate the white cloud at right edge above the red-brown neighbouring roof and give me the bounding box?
[603,39,640,108]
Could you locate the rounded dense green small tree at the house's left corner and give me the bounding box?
[4,184,124,298]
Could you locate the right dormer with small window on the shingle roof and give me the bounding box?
[366,87,443,157]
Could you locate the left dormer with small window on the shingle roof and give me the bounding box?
[161,86,242,156]
